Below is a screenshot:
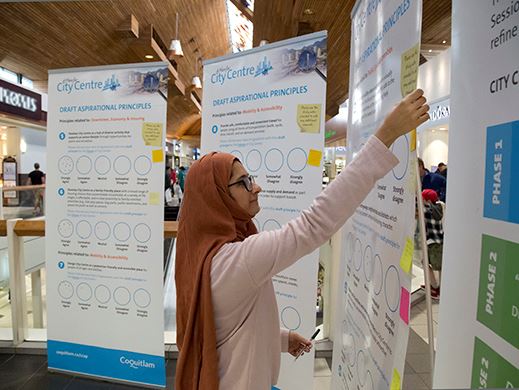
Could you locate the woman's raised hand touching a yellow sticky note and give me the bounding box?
[375,89,429,148]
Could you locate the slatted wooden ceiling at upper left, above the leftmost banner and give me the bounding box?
[0,0,230,143]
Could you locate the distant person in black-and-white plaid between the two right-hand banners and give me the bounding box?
[422,189,443,299]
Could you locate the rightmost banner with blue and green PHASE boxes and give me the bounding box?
[433,0,519,389]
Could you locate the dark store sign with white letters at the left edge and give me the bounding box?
[0,80,41,120]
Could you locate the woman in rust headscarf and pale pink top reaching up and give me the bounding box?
[175,90,429,390]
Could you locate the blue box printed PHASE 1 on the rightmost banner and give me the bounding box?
[483,121,519,223]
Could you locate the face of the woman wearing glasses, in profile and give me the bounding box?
[229,161,261,218]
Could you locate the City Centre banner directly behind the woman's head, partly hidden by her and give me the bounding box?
[202,32,327,390]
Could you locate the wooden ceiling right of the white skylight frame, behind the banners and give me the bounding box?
[253,0,452,117]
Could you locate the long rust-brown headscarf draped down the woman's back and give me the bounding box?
[175,153,257,390]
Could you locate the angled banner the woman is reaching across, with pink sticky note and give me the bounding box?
[332,0,422,390]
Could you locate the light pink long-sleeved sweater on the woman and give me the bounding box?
[211,136,398,390]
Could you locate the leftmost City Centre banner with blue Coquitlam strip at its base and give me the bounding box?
[45,62,168,387]
